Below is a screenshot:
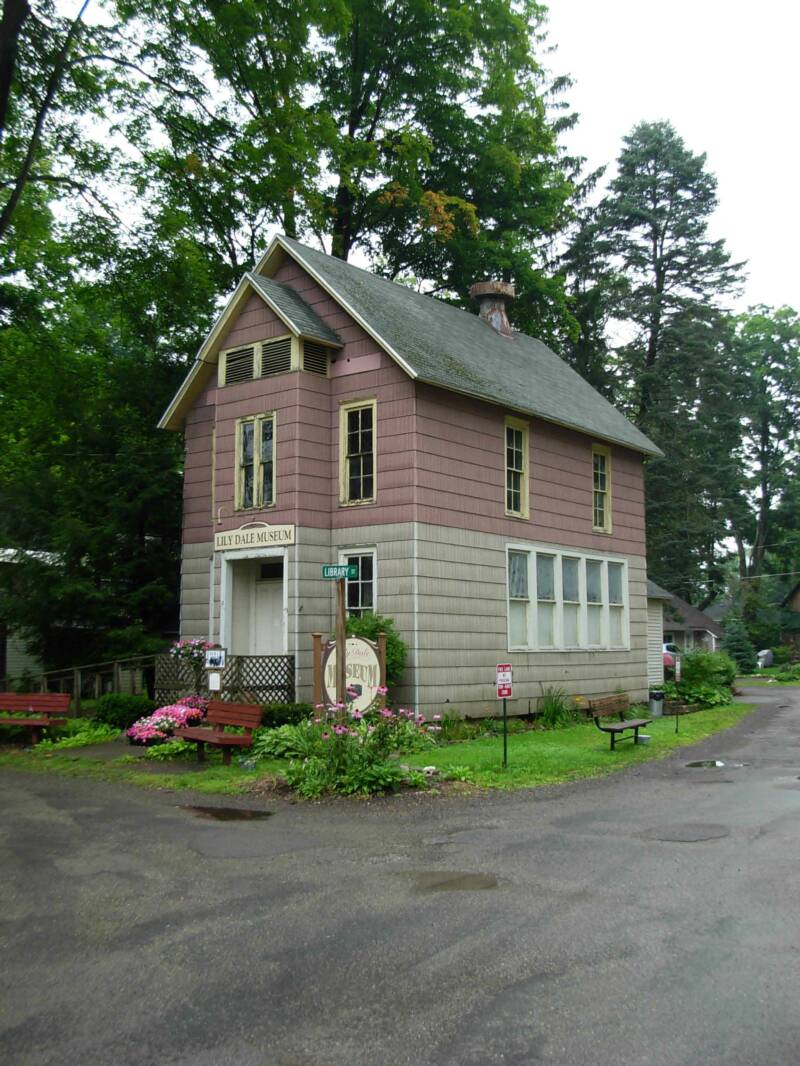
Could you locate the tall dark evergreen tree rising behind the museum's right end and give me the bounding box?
[571,123,741,601]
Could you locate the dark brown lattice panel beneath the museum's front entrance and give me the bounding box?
[156,656,294,706]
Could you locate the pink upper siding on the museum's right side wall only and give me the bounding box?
[416,385,644,554]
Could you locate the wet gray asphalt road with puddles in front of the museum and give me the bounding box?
[0,689,800,1066]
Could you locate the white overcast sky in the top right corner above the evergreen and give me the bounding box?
[547,0,800,309]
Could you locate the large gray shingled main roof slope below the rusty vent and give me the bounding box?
[281,237,661,455]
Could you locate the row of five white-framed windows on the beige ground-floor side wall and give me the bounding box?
[507,545,629,651]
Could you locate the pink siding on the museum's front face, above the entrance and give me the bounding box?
[183,255,415,542]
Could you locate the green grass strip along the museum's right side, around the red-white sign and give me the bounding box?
[407,704,753,789]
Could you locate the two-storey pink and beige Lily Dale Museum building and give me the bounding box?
[160,237,660,714]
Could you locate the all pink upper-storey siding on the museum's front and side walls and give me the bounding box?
[178,249,644,555]
